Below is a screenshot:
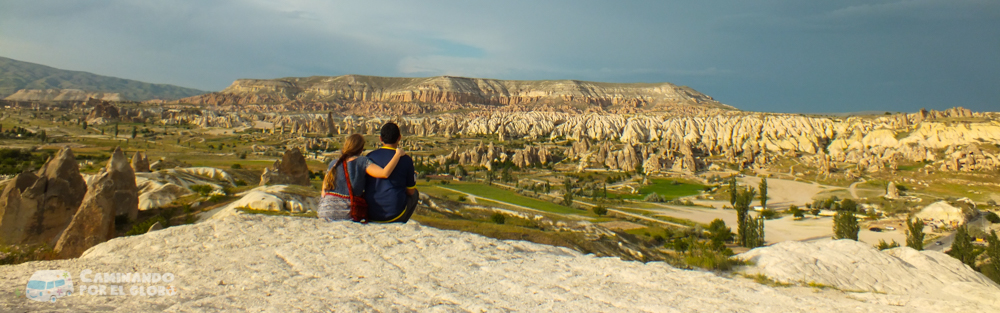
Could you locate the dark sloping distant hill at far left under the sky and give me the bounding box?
[0,57,206,101]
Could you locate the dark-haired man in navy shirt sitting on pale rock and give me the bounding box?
[365,122,419,223]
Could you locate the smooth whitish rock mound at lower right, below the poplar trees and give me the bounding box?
[739,240,1000,312]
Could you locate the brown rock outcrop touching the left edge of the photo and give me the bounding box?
[0,148,87,246]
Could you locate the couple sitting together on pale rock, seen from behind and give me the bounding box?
[317,122,418,223]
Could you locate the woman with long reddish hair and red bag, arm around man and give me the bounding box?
[316,134,406,222]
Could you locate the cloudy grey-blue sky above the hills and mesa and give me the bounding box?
[0,0,1000,113]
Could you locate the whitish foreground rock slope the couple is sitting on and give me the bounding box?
[0,215,995,312]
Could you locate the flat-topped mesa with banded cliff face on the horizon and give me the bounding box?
[178,75,732,109]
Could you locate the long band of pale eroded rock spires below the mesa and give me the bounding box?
[145,103,1000,175]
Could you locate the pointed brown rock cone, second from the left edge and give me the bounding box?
[55,148,139,258]
